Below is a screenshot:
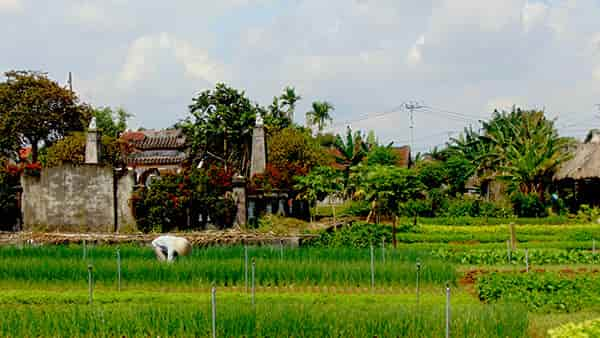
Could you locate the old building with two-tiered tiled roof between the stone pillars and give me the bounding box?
[121,129,188,185]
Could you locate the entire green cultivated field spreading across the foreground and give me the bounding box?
[0,225,600,337]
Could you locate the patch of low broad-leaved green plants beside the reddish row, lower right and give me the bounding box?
[475,273,600,312]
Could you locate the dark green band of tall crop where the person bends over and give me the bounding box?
[0,246,457,288]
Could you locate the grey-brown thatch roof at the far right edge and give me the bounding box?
[554,130,600,180]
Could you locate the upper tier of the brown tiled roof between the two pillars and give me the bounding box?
[121,129,185,150]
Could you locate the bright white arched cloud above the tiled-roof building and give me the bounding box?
[119,32,225,88]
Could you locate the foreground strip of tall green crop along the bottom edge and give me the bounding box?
[0,292,528,337]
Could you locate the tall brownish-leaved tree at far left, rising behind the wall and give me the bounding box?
[0,71,90,162]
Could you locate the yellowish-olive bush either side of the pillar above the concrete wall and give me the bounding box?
[40,132,125,167]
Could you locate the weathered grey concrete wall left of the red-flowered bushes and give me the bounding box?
[21,165,135,232]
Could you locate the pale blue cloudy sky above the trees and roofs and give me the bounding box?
[0,0,600,152]
